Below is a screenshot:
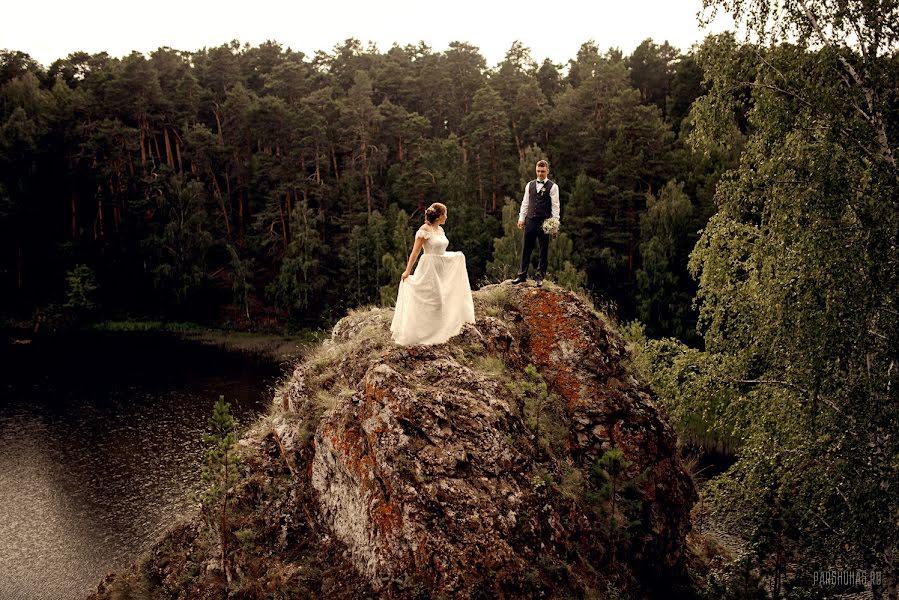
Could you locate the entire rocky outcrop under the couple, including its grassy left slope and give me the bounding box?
[95,283,696,598]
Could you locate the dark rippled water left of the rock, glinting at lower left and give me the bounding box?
[0,333,282,600]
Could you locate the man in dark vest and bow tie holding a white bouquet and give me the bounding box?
[512,160,559,287]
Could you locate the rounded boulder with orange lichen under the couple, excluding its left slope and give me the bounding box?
[281,284,695,596]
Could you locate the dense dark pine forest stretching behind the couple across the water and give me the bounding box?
[0,40,717,342]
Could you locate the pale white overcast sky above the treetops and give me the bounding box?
[0,0,733,67]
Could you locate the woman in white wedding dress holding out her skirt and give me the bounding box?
[390,202,474,346]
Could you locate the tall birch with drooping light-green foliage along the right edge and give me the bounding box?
[641,8,899,597]
